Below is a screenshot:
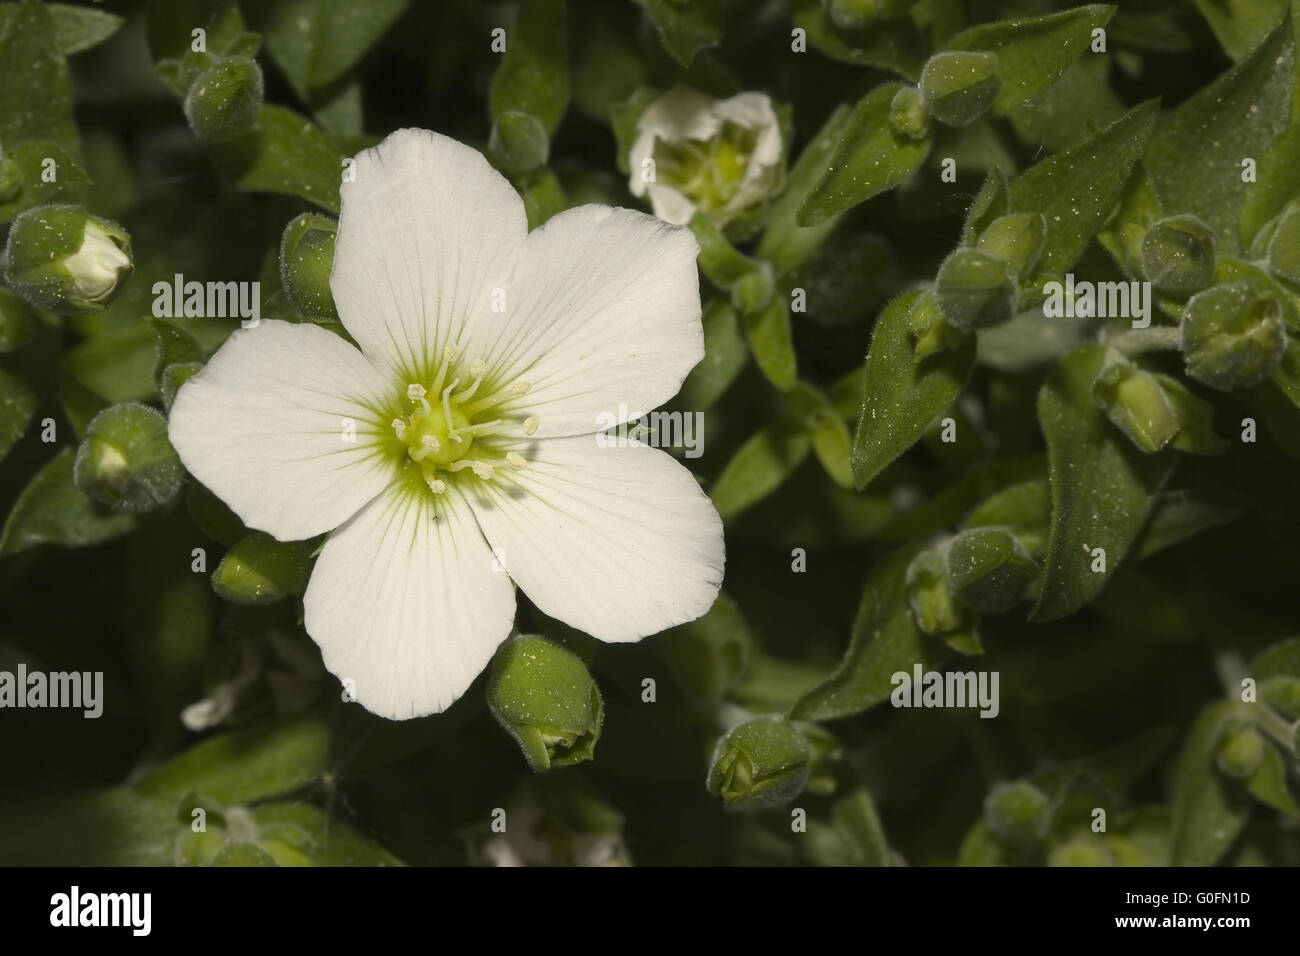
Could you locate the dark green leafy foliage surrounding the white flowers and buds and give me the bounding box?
[0,0,1300,865]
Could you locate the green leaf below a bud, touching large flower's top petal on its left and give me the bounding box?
[212,105,343,216]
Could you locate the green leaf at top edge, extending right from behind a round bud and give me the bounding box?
[944,4,1115,113]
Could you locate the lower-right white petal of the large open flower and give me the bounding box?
[469,436,724,641]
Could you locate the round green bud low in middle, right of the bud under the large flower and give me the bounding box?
[707,717,813,810]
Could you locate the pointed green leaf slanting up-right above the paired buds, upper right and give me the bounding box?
[1010,100,1160,274]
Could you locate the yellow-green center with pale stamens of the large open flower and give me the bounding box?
[393,345,538,494]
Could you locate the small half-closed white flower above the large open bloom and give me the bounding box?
[628,87,784,226]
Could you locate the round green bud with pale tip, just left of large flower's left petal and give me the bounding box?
[73,402,185,514]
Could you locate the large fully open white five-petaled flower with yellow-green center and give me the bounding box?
[170,130,723,718]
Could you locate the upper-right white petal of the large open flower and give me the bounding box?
[465,206,705,437]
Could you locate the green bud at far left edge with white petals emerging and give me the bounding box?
[4,204,133,315]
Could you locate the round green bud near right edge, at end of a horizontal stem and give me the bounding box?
[1179,282,1287,392]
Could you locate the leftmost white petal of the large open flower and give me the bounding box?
[168,319,391,541]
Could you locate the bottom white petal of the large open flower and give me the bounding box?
[303,486,515,721]
